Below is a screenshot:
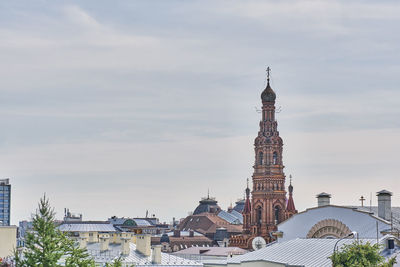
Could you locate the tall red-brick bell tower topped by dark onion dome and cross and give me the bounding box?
[230,68,297,249]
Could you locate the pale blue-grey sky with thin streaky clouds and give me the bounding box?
[0,0,400,224]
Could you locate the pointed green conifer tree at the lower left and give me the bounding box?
[14,195,95,267]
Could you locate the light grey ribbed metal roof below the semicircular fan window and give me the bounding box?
[227,238,376,267]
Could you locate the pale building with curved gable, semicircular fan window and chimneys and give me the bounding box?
[276,190,400,242]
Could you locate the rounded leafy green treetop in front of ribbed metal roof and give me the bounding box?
[329,241,396,267]
